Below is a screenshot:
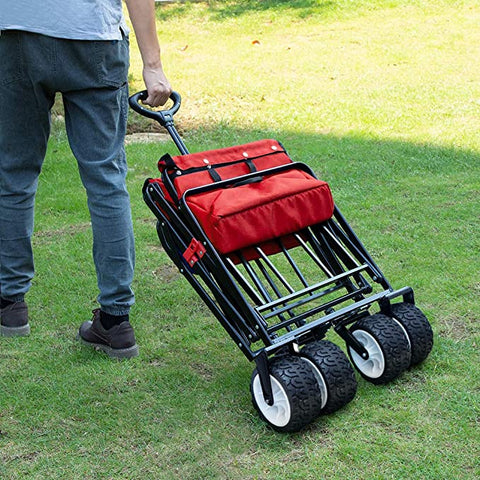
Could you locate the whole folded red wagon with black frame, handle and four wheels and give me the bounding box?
[130,92,433,432]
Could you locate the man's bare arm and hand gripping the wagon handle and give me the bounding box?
[125,0,172,107]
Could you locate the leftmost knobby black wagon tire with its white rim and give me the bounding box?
[250,355,321,432]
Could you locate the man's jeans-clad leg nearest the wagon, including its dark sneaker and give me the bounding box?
[57,39,138,357]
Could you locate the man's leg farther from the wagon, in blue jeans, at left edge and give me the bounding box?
[0,32,54,335]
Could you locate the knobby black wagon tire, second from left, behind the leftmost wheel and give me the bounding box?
[300,340,357,415]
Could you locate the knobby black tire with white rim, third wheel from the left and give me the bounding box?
[348,313,411,385]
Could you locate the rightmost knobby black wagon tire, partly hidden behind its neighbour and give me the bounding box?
[392,302,433,366]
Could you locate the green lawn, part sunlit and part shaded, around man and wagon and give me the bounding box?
[0,0,480,480]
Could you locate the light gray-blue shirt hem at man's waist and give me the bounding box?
[0,0,128,40]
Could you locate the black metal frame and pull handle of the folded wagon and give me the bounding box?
[131,90,414,404]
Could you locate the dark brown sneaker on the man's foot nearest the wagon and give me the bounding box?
[78,309,138,358]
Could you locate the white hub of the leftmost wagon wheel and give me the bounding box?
[253,375,292,427]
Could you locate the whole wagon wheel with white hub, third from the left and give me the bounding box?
[348,313,411,384]
